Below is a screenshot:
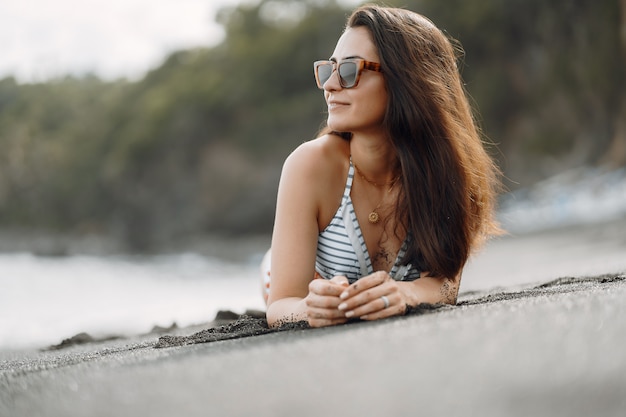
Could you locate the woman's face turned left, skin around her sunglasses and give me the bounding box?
[324,27,387,134]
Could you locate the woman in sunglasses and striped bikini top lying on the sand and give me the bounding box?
[267,5,498,327]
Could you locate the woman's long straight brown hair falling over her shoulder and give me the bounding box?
[330,5,500,278]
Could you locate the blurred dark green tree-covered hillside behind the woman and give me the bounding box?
[0,0,626,251]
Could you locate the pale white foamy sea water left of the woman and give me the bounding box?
[0,253,265,349]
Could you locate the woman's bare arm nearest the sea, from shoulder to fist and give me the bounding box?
[267,137,348,326]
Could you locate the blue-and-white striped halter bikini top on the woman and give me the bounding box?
[315,159,420,283]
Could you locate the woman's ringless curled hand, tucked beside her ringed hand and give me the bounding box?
[304,276,349,327]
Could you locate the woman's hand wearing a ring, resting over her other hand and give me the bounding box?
[336,271,408,320]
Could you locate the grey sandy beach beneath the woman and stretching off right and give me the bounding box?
[0,216,626,417]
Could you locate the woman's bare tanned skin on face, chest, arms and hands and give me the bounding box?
[267,27,460,327]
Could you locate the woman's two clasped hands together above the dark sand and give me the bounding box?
[305,271,406,327]
